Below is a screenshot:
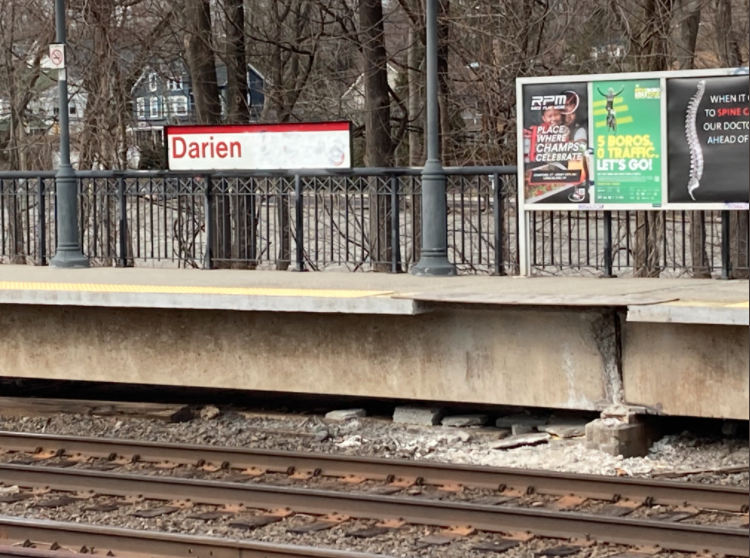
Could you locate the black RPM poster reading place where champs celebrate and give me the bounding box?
[523,83,589,204]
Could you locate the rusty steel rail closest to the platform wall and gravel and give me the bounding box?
[0,432,749,512]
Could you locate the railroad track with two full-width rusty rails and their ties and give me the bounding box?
[0,433,750,556]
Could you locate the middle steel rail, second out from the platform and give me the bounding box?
[0,465,750,557]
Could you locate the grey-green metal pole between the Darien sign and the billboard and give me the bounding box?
[412,0,456,277]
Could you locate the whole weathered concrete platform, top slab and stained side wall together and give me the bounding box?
[0,266,750,419]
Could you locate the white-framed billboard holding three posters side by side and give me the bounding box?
[516,69,750,211]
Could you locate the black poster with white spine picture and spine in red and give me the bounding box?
[667,76,750,204]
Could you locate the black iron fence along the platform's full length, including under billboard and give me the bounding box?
[0,167,750,277]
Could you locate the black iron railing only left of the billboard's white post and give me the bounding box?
[0,167,518,274]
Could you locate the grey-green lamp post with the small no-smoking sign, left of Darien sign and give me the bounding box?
[50,0,89,268]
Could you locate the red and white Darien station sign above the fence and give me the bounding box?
[165,122,352,171]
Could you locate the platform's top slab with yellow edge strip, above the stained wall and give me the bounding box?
[0,266,750,326]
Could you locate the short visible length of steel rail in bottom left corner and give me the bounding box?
[0,516,383,558]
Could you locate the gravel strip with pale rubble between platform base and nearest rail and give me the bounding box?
[0,412,750,486]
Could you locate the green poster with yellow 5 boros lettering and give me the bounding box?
[592,79,663,205]
